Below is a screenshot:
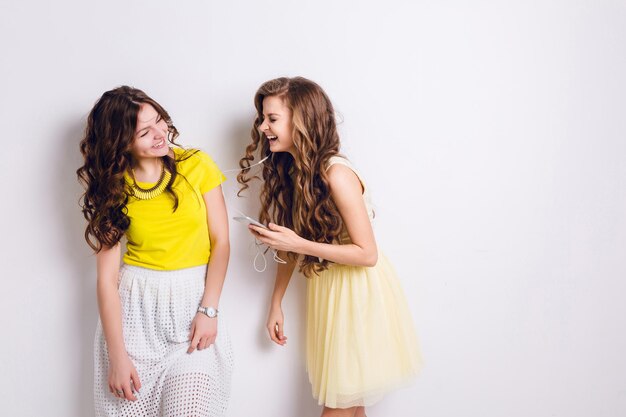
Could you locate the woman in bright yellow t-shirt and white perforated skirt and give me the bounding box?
[77,86,232,417]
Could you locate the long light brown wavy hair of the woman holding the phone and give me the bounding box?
[237,77,343,277]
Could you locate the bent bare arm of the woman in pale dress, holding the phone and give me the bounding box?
[249,164,378,266]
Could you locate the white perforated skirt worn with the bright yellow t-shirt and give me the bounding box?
[94,265,233,417]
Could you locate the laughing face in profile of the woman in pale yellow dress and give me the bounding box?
[259,96,295,155]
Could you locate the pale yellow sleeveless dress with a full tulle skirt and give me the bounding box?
[306,156,421,408]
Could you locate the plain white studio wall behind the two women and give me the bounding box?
[0,0,626,417]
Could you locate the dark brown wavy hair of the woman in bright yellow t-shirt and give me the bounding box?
[76,86,188,253]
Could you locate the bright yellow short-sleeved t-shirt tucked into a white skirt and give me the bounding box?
[124,148,226,270]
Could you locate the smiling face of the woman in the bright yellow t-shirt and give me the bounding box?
[131,103,170,161]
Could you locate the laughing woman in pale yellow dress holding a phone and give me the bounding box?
[238,77,420,417]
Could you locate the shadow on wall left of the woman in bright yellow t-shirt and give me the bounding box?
[56,115,98,416]
